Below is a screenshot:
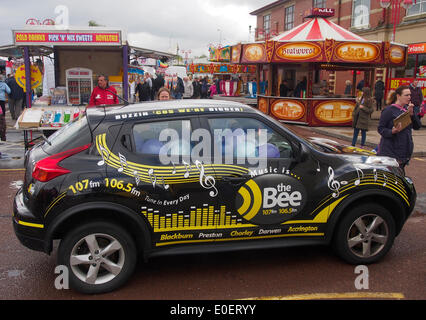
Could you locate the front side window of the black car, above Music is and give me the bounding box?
[208,118,293,158]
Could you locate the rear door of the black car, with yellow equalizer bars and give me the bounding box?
[102,116,223,248]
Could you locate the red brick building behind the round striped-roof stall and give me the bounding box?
[250,0,426,96]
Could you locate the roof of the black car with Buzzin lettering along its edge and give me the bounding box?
[86,99,259,121]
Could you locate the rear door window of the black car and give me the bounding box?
[132,120,191,156]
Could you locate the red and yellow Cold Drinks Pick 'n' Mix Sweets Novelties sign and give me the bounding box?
[13,30,121,46]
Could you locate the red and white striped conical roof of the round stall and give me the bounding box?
[272,17,368,42]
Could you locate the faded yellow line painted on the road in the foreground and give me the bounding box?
[240,292,405,300]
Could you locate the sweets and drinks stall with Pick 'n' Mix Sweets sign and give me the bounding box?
[0,25,174,149]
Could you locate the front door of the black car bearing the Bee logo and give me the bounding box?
[201,114,323,241]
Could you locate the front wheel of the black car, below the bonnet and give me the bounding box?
[333,203,395,265]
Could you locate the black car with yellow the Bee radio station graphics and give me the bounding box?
[13,100,416,293]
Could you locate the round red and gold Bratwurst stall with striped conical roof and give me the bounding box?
[231,8,407,126]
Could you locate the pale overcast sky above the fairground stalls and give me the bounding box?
[0,0,275,56]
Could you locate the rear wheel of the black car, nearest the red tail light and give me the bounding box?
[58,221,137,294]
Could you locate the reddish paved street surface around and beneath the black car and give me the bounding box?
[0,105,426,300]
